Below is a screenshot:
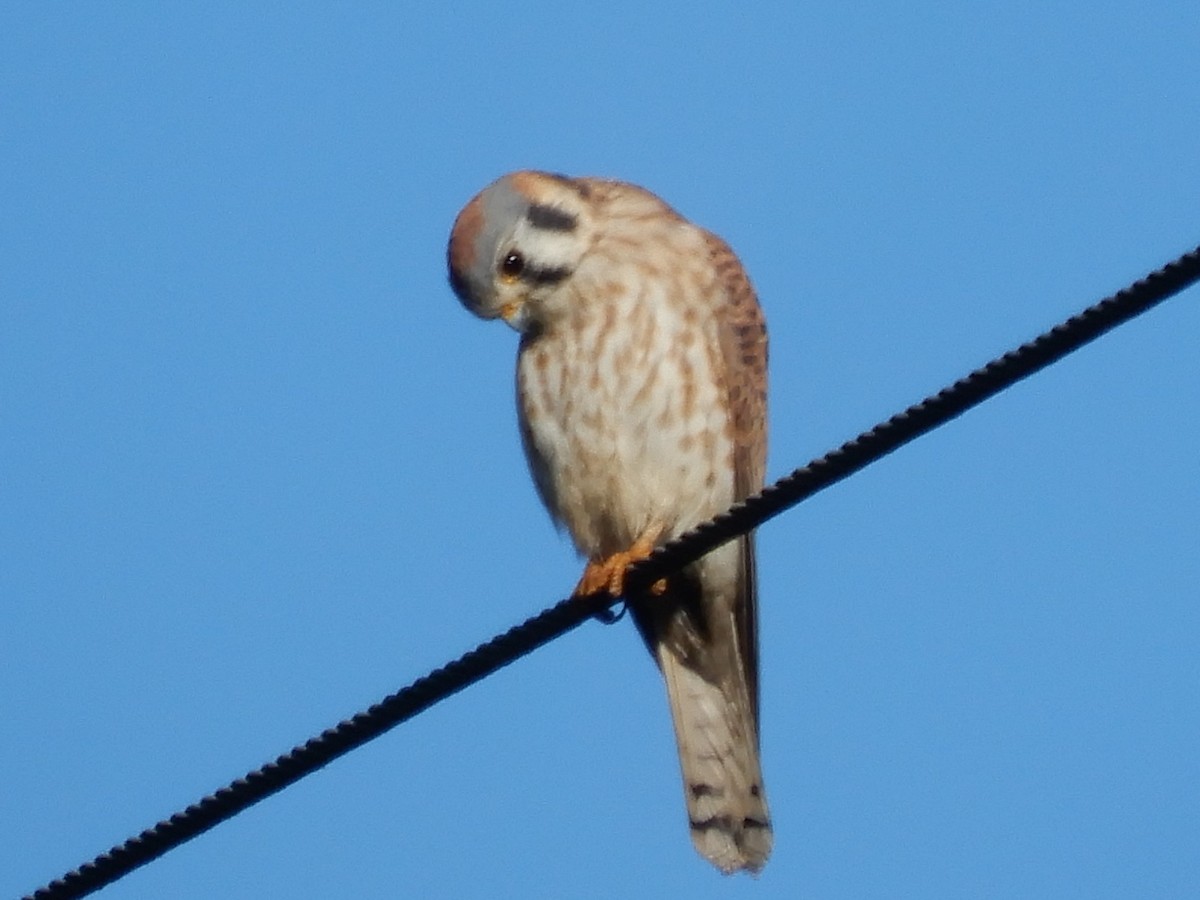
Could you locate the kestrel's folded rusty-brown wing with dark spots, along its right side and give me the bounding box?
[707,234,767,724]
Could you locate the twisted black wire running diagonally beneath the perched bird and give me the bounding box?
[25,241,1200,900]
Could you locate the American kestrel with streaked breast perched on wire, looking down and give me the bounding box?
[448,172,772,872]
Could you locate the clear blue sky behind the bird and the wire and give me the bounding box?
[0,2,1200,899]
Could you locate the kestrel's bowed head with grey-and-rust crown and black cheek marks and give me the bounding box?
[446,172,590,331]
